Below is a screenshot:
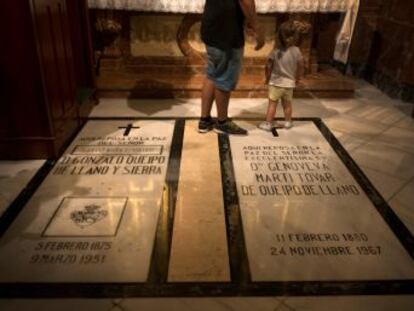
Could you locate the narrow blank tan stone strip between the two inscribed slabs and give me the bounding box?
[168,121,230,282]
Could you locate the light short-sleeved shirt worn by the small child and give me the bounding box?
[269,46,303,88]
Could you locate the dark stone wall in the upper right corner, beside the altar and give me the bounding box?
[350,0,414,102]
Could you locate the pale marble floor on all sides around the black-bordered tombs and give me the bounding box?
[0,81,414,311]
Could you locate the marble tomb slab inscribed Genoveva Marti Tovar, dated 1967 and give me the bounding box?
[229,121,414,282]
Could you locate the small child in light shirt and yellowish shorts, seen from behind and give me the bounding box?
[259,21,304,131]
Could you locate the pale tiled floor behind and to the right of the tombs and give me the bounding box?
[92,80,414,234]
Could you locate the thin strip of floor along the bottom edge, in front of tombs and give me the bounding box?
[0,296,414,311]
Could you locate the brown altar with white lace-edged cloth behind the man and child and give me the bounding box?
[89,0,359,98]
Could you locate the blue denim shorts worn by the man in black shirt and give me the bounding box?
[206,46,243,92]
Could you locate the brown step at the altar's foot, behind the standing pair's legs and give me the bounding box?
[97,67,354,98]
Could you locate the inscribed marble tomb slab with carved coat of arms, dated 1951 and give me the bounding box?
[0,120,175,283]
